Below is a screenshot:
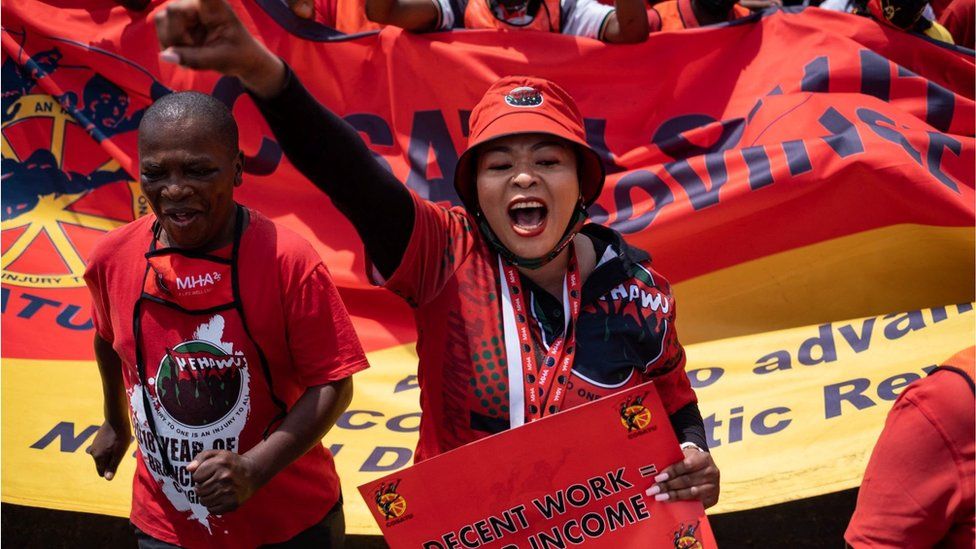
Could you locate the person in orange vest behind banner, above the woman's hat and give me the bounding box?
[366,0,648,43]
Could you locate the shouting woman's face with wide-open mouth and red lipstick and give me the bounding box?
[477,133,580,259]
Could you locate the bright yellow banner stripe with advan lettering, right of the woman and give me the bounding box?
[687,303,976,513]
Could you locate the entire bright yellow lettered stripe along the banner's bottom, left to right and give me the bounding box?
[2,304,976,534]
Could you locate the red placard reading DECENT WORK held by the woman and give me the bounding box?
[359,382,715,549]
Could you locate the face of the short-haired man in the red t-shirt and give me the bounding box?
[139,116,243,249]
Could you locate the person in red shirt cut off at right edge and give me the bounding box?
[844,347,976,549]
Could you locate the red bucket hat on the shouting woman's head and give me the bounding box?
[454,76,604,212]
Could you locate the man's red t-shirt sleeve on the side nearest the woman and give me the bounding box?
[285,263,369,387]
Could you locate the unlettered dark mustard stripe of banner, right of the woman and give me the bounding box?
[672,225,976,345]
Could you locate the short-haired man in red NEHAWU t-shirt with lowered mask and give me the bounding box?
[85,92,367,548]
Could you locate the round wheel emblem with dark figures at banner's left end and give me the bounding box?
[2,38,149,288]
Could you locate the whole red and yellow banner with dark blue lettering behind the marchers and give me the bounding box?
[0,0,976,533]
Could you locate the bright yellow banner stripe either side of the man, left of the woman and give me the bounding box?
[0,344,420,534]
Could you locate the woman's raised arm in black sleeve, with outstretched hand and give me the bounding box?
[156,0,414,277]
